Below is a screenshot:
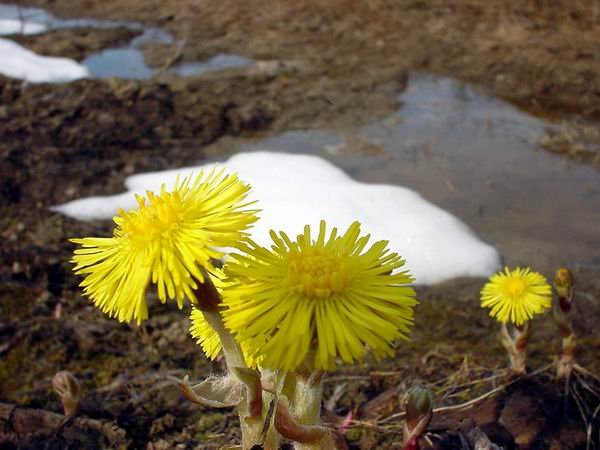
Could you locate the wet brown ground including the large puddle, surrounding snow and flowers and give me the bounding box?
[0,0,600,449]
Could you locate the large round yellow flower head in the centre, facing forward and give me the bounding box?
[223,221,416,370]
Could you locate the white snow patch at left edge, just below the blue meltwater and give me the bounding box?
[0,38,90,83]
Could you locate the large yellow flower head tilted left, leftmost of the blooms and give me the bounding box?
[71,168,256,323]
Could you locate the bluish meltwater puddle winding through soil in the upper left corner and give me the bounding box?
[0,5,254,79]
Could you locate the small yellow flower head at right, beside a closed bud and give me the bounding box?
[481,267,552,325]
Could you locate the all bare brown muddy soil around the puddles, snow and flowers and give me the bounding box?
[0,0,600,449]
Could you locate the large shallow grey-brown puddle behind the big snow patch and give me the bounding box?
[209,75,600,271]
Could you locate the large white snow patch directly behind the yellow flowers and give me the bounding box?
[52,152,500,284]
